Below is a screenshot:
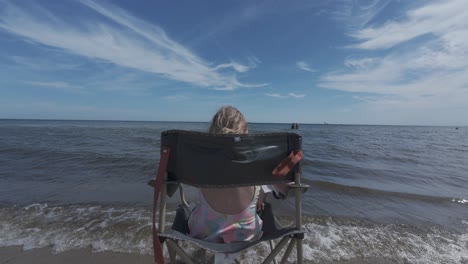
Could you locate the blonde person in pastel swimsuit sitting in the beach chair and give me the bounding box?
[188,106,263,243]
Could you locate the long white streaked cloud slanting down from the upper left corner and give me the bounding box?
[0,0,261,90]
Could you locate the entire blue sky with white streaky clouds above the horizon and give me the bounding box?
[0,0,468,125]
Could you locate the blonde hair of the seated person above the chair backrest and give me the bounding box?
[209,105,249,134]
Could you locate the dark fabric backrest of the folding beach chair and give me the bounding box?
[161,130,302,188]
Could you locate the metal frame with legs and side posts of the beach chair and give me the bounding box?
[152,131,309,264]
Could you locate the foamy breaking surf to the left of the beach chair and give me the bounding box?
[0,204,155,254]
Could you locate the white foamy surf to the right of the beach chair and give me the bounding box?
[304,219,468,264]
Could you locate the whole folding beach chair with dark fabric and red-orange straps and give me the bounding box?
[148,130,308,263]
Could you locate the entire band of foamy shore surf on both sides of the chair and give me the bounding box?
[0,204,468,264]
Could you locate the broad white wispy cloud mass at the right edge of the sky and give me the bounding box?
[319,0,468,113]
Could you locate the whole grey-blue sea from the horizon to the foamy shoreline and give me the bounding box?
[0,120,468,264]
